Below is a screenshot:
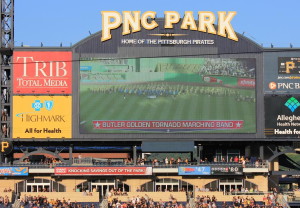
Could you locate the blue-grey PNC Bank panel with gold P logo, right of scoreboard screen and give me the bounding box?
[264,57,300,94]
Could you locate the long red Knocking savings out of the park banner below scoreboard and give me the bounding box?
[54,167,152,176]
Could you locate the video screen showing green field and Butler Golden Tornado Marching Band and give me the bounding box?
[80,57,256,133]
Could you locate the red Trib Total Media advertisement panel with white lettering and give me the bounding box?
[13,51,72,94]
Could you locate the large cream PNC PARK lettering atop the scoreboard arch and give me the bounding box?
[101,11,238,42]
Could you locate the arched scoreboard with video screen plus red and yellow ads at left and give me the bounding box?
[12,17,264,141]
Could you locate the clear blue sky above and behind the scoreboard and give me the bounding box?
[15,0,300,47]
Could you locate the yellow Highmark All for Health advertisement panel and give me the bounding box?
[13,96,72,139]
